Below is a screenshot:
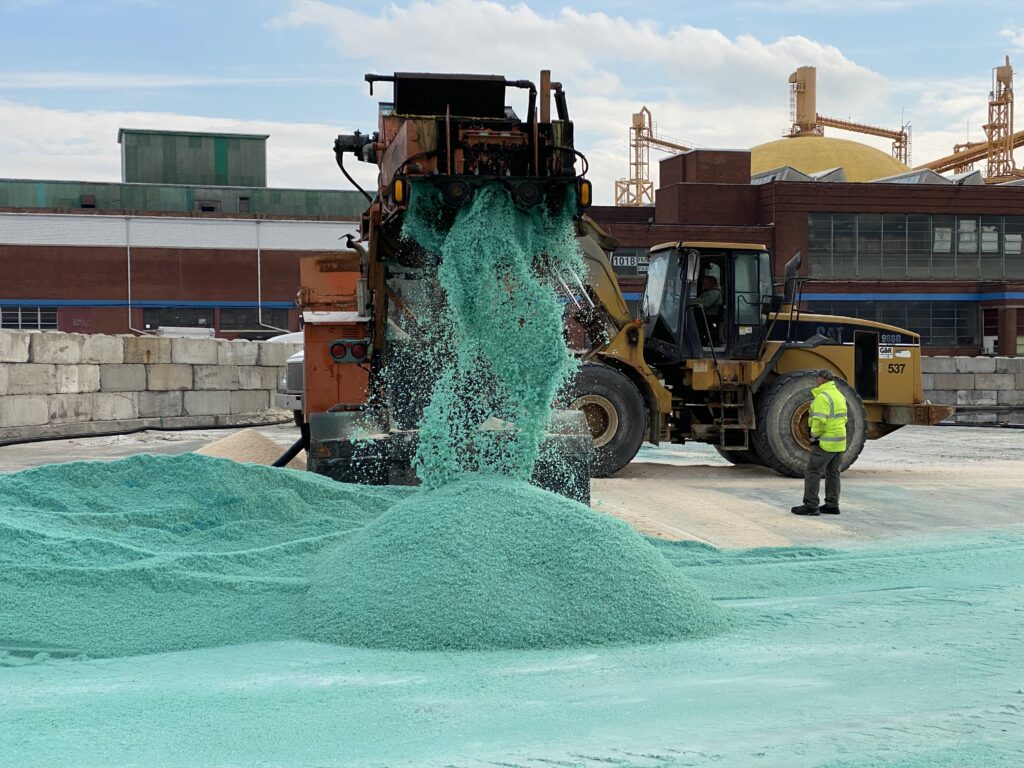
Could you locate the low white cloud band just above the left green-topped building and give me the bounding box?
[0,99,377,189]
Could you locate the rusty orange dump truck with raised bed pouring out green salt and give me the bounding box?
[299,72,591,493]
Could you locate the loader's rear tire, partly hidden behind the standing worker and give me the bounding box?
[754,371,867,477]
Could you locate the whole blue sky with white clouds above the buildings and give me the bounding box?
[0,0,1024,204]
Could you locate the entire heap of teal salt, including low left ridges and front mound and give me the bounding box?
[0,455,725,664]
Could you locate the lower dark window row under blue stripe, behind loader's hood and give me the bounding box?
[807,299,982,347]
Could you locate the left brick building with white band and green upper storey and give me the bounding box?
[0,130,366,338]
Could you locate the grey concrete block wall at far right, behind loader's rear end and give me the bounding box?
[922,357,1024,410]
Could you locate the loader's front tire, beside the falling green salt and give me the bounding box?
[568,362,647,477]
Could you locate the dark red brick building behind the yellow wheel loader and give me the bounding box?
[591,150,1024,354]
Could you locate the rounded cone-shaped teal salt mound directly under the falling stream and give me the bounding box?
[306,474,724,650]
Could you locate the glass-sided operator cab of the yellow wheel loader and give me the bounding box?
[641,243,773,365]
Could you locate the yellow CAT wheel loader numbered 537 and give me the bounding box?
[567,217,953,477]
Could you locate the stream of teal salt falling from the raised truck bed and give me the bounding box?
[403,183,581,488]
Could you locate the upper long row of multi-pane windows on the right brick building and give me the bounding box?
[807,213,1024,280]
